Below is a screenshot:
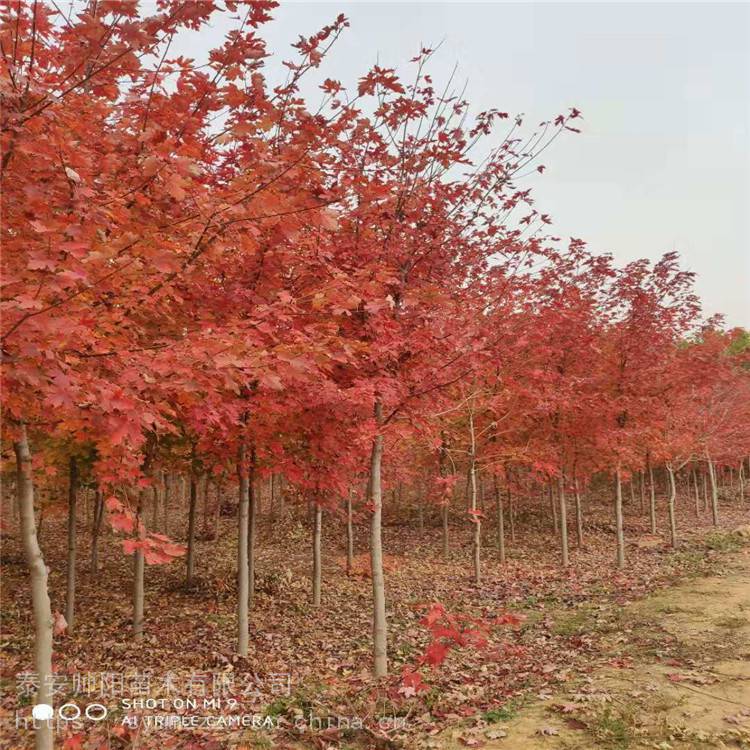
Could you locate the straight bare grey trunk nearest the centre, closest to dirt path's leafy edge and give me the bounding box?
[370,402,388,677]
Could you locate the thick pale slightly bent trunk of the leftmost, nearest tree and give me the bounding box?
[13,423,53,750]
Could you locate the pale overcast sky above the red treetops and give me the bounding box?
[170,2,750,327]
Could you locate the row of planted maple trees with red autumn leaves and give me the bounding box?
[0,0,750,748]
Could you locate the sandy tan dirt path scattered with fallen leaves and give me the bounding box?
[434,548,750,750]
